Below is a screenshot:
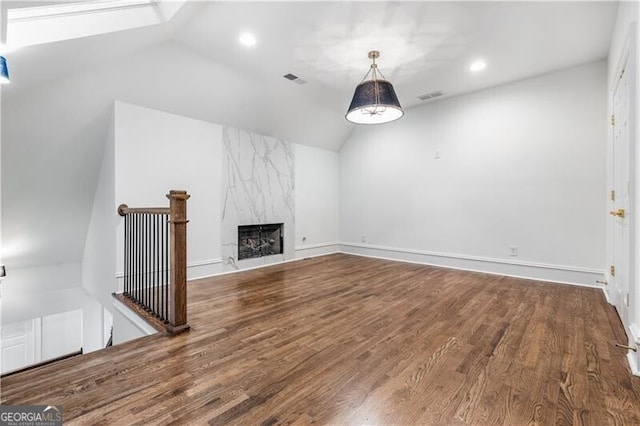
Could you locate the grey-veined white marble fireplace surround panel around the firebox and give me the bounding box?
[221,126,295,271]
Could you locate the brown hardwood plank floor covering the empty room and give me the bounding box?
[1,254,640,425]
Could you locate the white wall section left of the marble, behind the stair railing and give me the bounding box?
[113,102,222,279]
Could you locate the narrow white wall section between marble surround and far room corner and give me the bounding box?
[295,145,340,258]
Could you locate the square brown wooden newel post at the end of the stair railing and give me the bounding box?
[167,190,190,333]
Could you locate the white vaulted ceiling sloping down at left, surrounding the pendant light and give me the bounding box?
[2,2,617,267]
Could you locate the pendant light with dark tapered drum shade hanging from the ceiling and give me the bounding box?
[345,50,404,124]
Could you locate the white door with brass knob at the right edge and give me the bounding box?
[610,54,632,329]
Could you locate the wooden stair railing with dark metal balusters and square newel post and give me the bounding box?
[114,190,190,334]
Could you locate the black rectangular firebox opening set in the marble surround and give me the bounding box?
[238,223,284,260]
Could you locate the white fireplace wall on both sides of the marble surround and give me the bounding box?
[114,102,339,279]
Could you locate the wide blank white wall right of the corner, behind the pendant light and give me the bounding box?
[340,61,606,285]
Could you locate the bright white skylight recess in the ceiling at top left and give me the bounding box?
[6,0,184,48]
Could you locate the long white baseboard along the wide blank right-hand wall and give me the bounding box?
[340,242,604,288]
